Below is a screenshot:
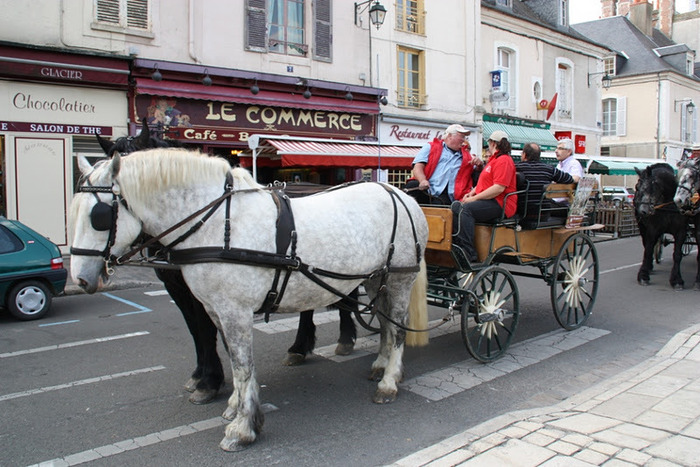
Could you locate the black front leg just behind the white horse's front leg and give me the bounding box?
[156,269,224,404]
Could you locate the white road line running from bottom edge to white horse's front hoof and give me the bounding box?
[29,403,279,467]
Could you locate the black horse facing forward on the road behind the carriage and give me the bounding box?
[634,163,688,290]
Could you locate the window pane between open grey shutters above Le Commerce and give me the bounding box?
[267,0,308,55]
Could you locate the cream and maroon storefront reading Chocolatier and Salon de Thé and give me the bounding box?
[0,45,129,251]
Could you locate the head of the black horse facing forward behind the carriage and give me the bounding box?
[634,163,676,218]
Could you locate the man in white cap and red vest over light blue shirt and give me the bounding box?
[406,124,483,205]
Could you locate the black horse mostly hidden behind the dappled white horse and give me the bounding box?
[97,119,357,404]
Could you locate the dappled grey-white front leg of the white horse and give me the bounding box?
[219,310,265,451]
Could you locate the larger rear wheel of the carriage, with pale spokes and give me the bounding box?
[551,233,599,331]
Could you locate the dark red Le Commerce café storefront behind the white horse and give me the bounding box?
[129,59,386,185]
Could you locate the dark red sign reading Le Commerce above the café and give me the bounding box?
[135,94,374,142]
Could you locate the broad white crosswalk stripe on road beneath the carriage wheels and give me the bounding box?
[400,326,610,401]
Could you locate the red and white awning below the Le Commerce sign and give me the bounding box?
[258,139,420,169]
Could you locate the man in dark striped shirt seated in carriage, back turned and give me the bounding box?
[515,143,574,221]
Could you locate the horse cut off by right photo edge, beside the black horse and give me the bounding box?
[673,158,700,290]
